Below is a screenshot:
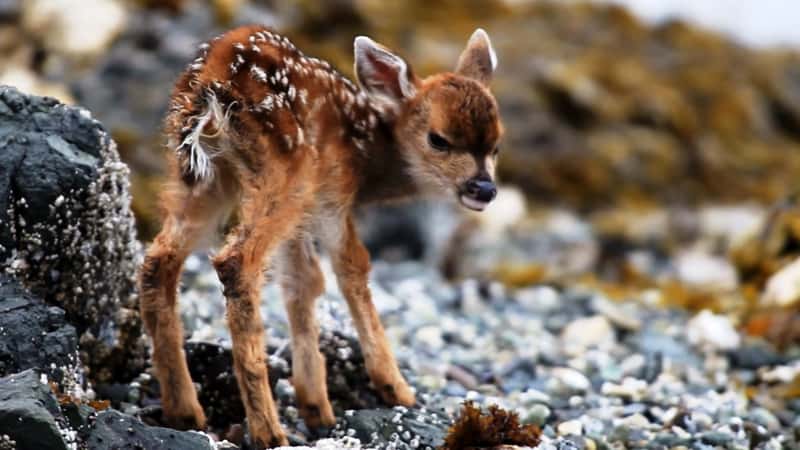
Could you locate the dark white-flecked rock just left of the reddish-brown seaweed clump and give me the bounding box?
[337,407,450,449]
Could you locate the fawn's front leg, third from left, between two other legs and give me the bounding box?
[280,233,336,428]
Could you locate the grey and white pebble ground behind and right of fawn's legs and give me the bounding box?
[170,256,800,450]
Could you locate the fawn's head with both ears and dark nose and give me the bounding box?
[355,29,503,211]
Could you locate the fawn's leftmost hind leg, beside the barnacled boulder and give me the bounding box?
[139,182,228,429]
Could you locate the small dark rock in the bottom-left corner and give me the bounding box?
[0,370,67,450]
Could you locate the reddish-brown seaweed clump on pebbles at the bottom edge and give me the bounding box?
[442,401,541,450]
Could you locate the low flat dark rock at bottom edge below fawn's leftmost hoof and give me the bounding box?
[87,409,214,450]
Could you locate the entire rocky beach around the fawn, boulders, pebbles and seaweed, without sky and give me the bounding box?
[0,0,800,450]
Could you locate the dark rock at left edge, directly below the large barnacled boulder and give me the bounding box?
[0,273,78,382]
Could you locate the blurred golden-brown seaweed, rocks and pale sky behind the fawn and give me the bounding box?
[0,0,800,343]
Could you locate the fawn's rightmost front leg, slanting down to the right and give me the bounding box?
[331,217,415,406]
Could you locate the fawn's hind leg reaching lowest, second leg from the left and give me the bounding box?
[213,167,309,448]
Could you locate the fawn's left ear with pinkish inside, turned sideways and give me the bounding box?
[353,36,417,102]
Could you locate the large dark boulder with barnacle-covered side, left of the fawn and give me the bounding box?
[0,87,144,380]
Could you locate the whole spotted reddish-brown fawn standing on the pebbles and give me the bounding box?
[140,26,502,447]
